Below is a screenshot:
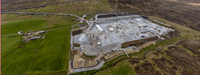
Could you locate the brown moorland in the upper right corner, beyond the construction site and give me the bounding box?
[108,0,200,31]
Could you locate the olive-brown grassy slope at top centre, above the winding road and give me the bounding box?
[18,0,114,16]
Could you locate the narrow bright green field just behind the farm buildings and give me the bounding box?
[1,19,46,35]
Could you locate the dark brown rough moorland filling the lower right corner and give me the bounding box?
[129,40,200,75]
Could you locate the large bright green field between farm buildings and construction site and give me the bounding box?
[2,28,71,75]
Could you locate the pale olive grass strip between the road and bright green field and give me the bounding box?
[1,14,77,28]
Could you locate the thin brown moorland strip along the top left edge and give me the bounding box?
[1,0,85,11]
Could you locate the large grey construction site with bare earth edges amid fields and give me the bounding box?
[69,14,176,73]
